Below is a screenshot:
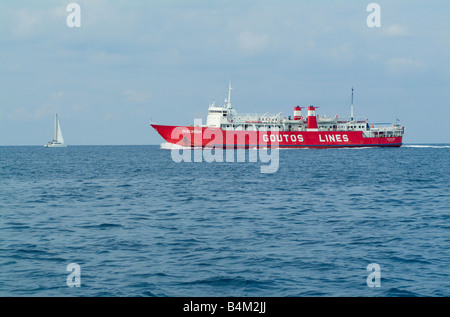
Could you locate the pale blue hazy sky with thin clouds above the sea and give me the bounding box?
[0,0,450,146]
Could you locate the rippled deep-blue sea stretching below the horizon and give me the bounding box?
[0,144,450,297]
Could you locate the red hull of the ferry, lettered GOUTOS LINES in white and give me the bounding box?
[152,124,402,148]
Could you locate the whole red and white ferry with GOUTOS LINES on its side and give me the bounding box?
[151,85,404,149]
